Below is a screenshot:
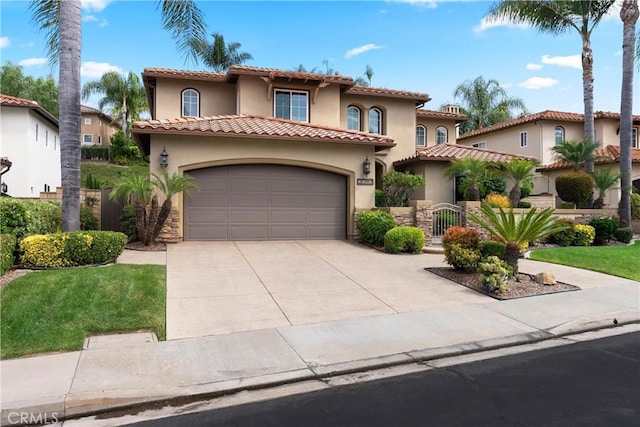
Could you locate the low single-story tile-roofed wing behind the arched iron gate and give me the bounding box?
[394,144,528,203]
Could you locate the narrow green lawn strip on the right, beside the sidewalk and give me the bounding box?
[531,241,640,281]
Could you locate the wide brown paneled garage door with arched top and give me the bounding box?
[184,165,347,240]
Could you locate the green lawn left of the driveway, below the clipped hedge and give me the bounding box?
[0,264,166,359]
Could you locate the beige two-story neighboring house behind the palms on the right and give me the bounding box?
[458,110,640,205]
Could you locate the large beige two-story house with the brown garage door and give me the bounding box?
[132,66,476,240]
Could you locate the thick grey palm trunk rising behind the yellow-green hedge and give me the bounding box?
[58,0,82,231]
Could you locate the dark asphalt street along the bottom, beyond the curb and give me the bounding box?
[127,333,640,427]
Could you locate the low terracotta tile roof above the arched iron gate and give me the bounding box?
[393,144,534,165]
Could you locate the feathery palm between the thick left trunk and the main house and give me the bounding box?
[82,71,147,138]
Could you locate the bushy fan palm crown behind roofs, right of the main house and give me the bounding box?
[453,76,527,133]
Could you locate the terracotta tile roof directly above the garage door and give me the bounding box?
[132,114,395,147]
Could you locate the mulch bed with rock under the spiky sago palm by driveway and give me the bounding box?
[425,267,580,300]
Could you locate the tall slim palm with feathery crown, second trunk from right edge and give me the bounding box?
[488,0,615,173]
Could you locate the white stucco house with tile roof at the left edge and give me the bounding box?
[0,95,61,198]
